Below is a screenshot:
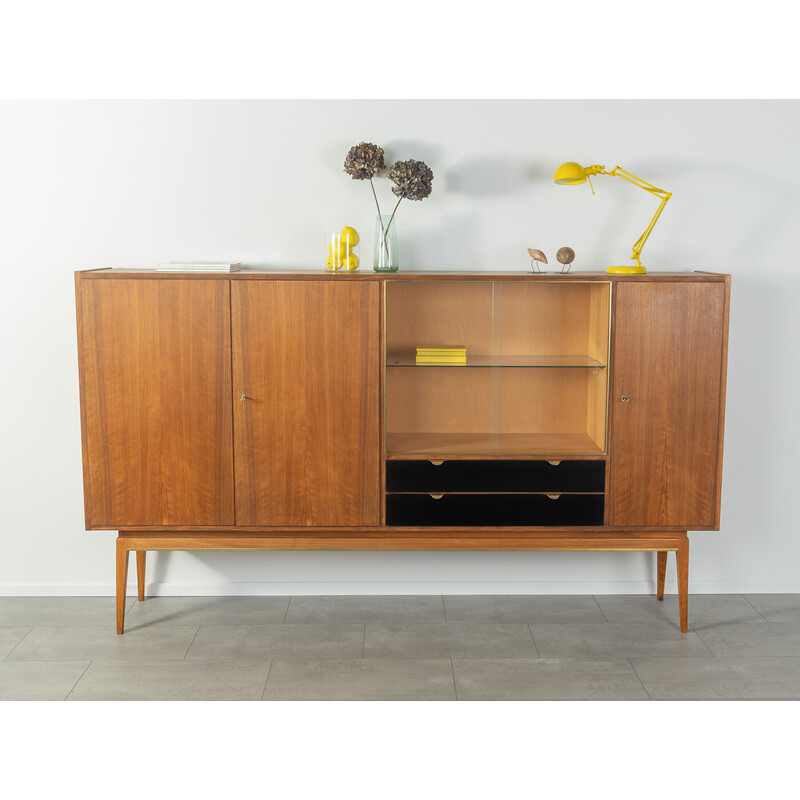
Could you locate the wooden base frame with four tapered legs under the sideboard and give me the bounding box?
[116,529,689,633]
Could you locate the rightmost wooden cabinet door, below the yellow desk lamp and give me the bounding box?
[607,281,728,530]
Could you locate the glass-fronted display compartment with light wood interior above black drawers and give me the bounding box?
[385,279,611,457]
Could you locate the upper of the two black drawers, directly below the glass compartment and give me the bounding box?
[386,460,606,493]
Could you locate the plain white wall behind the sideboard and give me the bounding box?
[0,100,800,595]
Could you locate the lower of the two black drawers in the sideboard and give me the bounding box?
[386,494,604,527]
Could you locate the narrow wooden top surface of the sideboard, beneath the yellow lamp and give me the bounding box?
[75,267,730,282]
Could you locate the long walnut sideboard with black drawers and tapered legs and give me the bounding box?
[75,270,730,633]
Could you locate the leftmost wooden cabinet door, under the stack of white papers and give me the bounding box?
[78,278,234,528]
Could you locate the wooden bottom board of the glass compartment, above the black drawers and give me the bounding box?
[386,433,603,458]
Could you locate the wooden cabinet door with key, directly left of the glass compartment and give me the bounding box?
[232,279,381,526]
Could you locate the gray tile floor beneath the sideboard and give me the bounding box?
[0,594,800,700]
